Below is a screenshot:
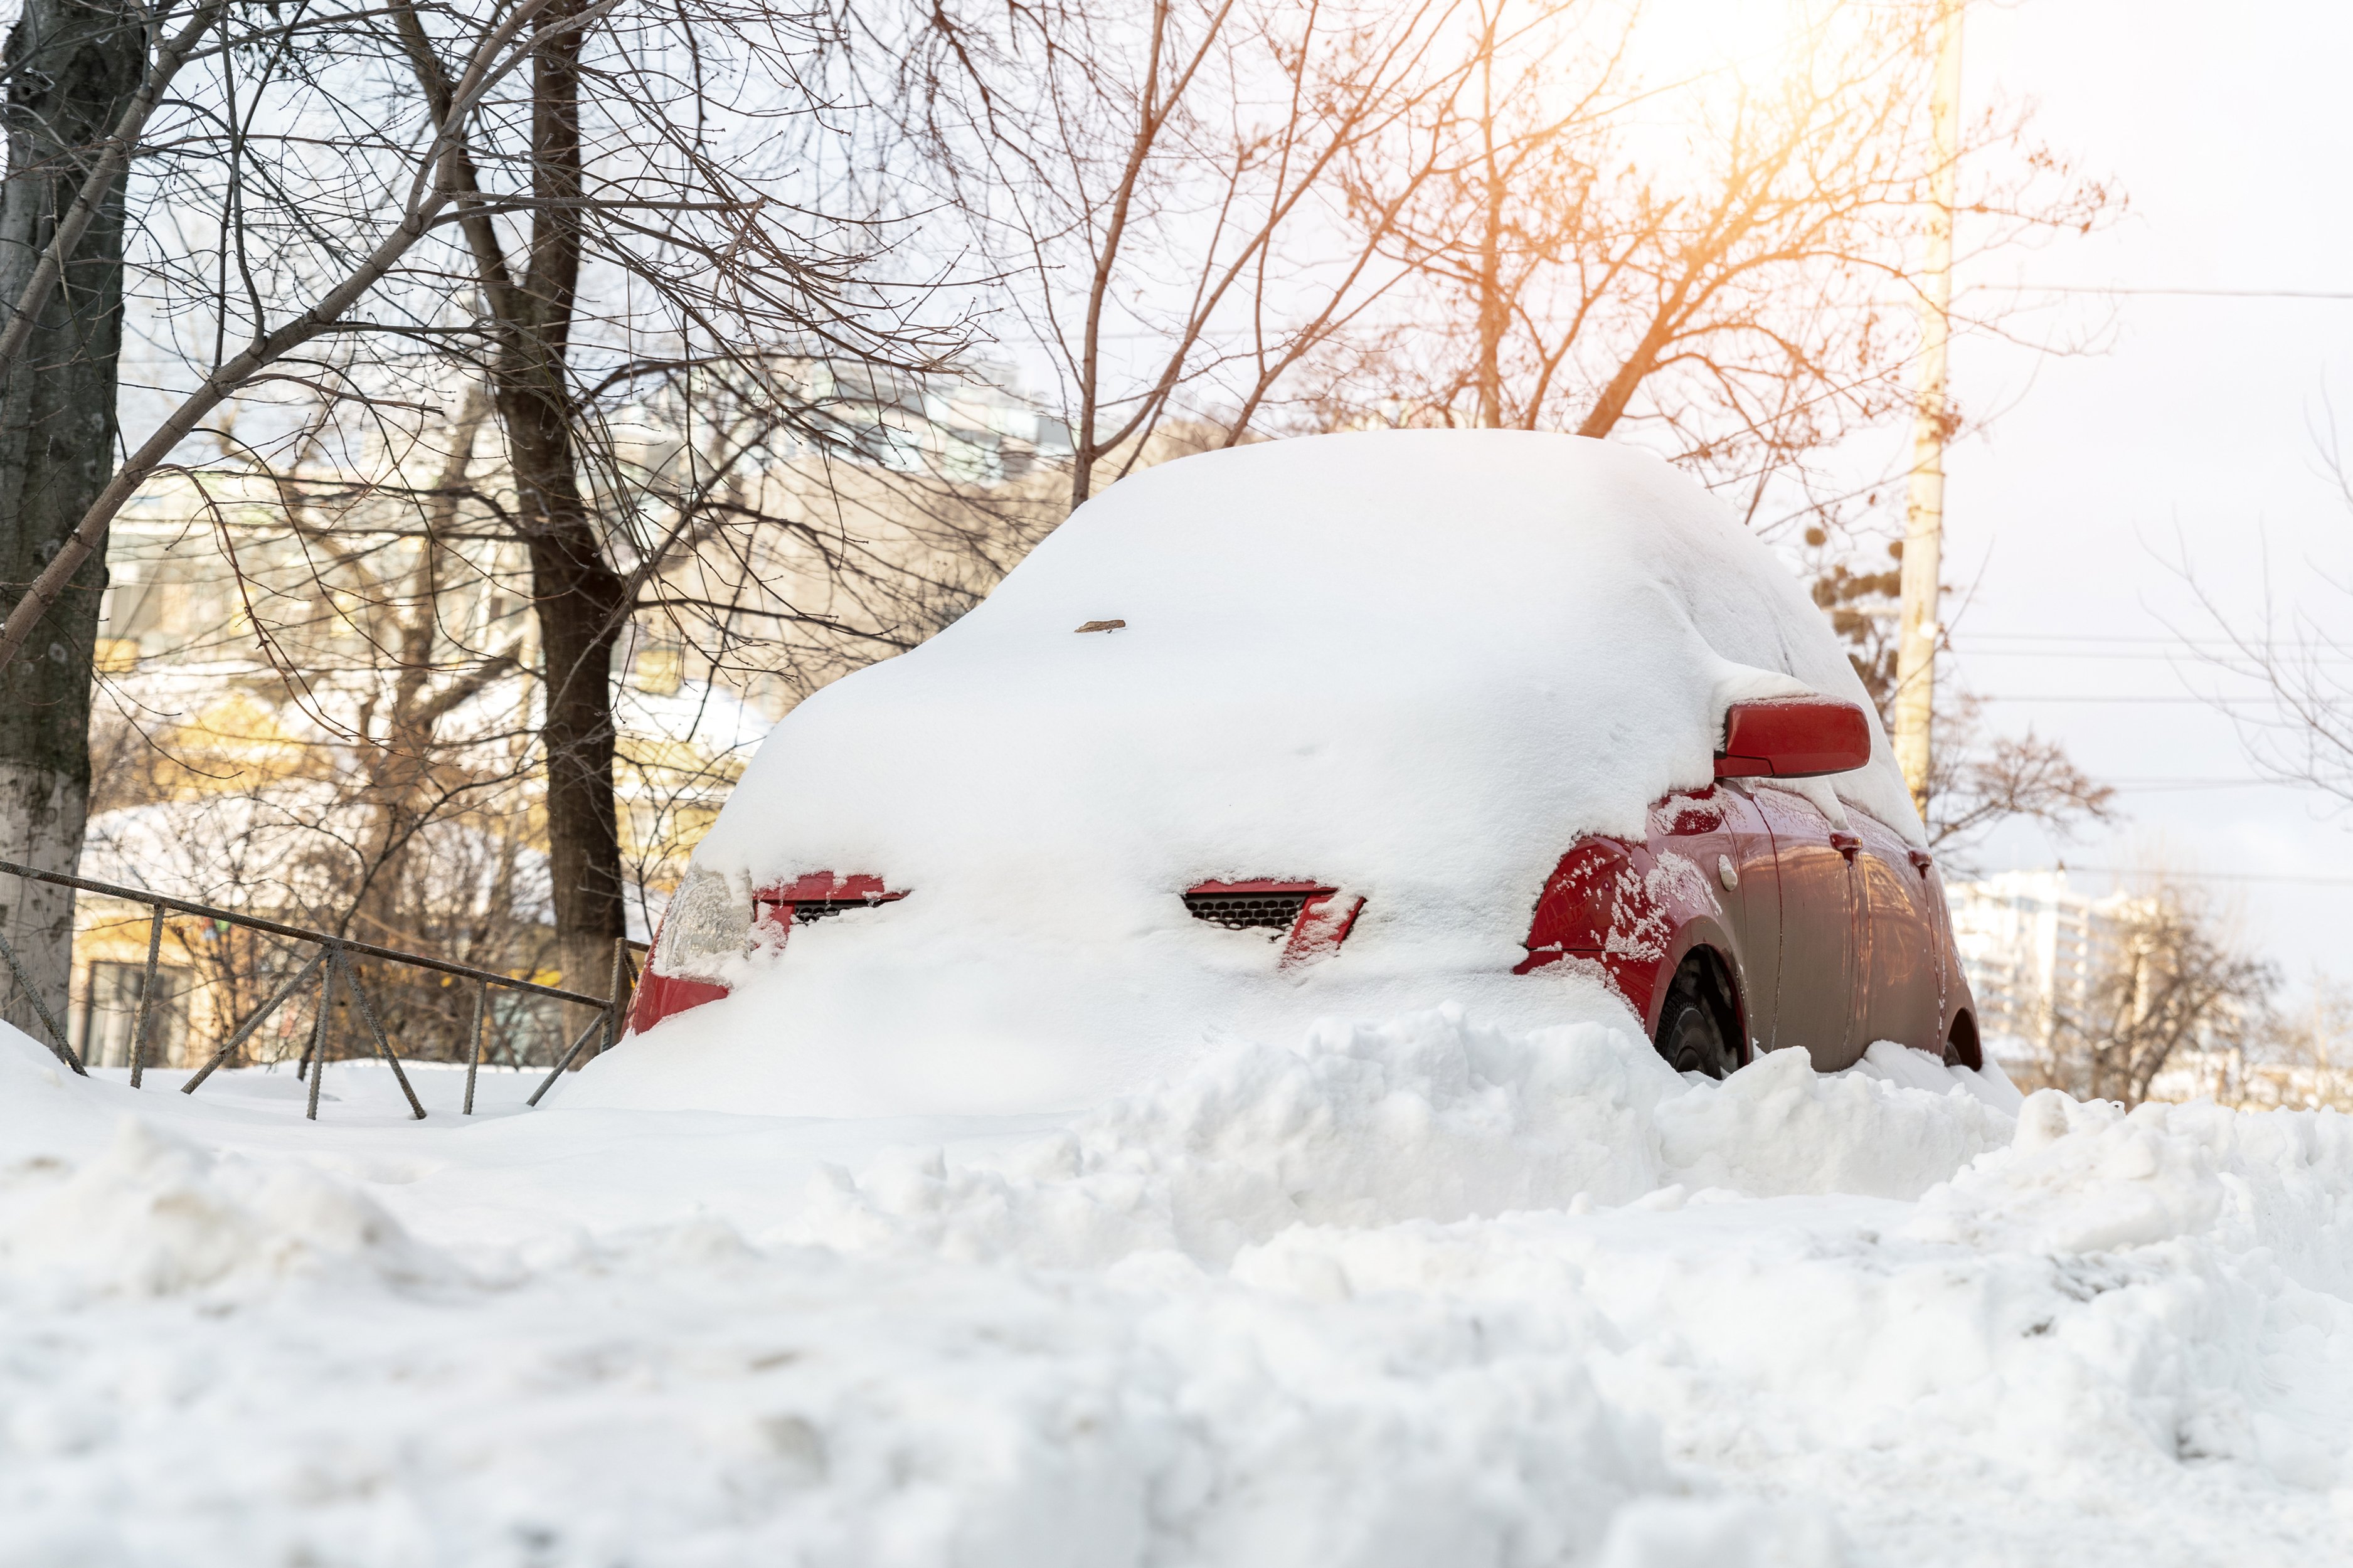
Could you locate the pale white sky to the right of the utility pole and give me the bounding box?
[1910,0,2353,980]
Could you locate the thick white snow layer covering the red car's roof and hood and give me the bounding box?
[567,431,1918,1114]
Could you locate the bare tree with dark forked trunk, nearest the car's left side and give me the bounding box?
[0,0,958,1012]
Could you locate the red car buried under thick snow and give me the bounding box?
[578,431,1979,1116]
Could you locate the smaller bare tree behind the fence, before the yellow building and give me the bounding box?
[92,396,553,1055]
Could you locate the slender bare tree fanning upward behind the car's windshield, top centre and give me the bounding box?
[890,0,1469,506]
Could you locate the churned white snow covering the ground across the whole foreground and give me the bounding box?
[0,1010,2353,1568]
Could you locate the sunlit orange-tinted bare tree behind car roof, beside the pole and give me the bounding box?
[1348,0,2120,504]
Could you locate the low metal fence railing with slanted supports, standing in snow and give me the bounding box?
[0,859,638,1121]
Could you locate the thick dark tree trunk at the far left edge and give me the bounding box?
[0,0,146,1034]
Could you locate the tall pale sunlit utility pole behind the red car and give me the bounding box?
[1894,0,1962,817]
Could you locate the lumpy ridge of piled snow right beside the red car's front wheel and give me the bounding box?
[802,1008,2017,1267]
